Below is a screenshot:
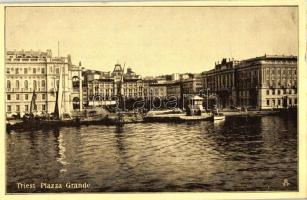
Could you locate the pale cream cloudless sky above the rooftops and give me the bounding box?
[5,7,298,76]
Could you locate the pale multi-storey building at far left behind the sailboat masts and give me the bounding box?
[5,50,82,114]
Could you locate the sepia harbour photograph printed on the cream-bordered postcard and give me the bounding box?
[3,0,303,198]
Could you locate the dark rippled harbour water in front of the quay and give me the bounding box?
[6,116,298,193]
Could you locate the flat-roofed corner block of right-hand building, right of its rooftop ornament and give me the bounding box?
[236,55,297,109]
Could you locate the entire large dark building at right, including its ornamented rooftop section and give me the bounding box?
[203,55,297,109]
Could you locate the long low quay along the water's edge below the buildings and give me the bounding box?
[6,110,296,131]
